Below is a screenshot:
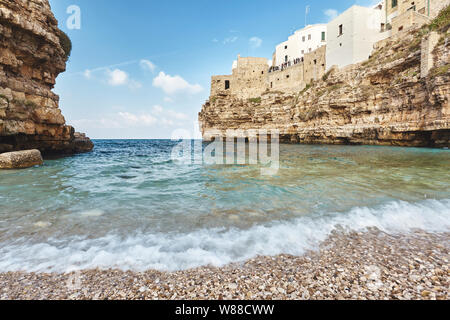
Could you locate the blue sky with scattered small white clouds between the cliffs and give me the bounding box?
[50,0,375,139]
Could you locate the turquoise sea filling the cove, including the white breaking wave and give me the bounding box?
[0,140,450,271]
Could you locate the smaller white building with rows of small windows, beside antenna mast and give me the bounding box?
[273,24,327,66]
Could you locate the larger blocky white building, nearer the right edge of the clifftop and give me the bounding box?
[326,3,390,70]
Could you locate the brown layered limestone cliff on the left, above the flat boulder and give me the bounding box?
[0,0,93,154]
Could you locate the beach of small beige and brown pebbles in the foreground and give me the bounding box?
[0,229,450,300]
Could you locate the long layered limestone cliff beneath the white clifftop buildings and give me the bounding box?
[199,26,450,147]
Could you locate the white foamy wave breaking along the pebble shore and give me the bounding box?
[0,199,450,272]
